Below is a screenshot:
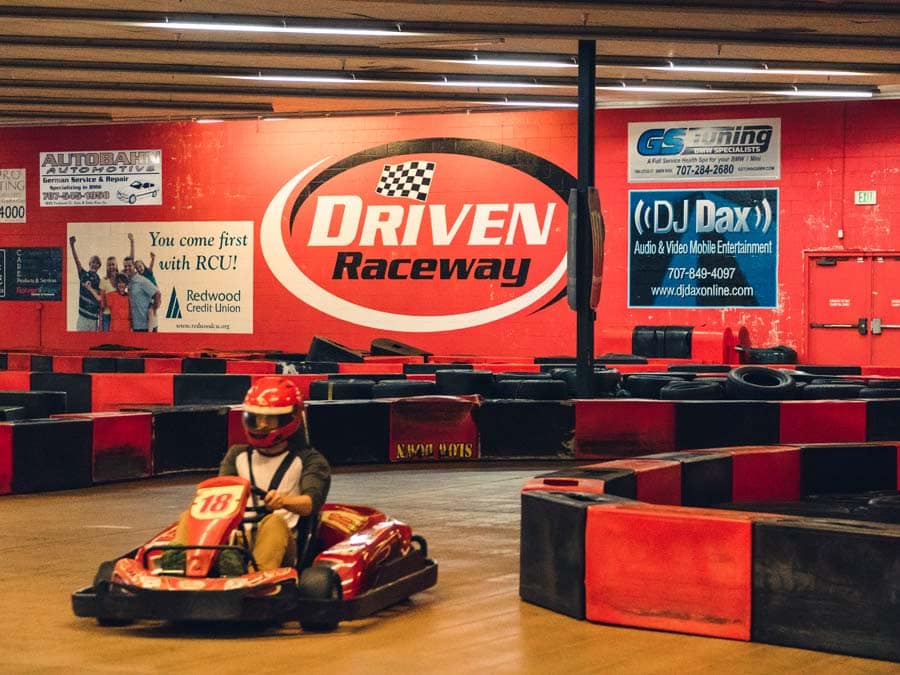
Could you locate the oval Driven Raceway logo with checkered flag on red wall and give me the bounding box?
[259,138,575,332]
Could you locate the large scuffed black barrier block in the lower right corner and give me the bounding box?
[751,519,900,661]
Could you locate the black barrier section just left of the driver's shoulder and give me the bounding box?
[123,405,228,474]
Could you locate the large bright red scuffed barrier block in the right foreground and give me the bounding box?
[585,503,765,640]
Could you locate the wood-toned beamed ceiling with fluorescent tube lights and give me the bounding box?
[0,0,900,126]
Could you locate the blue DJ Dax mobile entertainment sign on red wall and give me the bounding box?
[628,189,778,307]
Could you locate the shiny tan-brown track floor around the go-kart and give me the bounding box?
[0,463,900,675]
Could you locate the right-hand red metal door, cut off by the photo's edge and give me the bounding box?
[870,256,900,366]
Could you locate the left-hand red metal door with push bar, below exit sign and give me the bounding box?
[806,255,872,365]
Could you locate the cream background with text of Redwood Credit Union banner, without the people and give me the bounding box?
[66,221,253,333]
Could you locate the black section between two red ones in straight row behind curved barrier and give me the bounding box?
[675,401,781,450]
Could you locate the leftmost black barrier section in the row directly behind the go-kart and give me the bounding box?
[10,419,93,493]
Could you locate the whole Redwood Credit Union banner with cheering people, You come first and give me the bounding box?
[66,221,253,333]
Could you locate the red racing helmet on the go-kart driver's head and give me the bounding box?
[241,377,303,448]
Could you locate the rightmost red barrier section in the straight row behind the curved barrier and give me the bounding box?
[779,400,866,443]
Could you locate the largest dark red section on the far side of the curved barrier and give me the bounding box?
[691,445,801,502]
